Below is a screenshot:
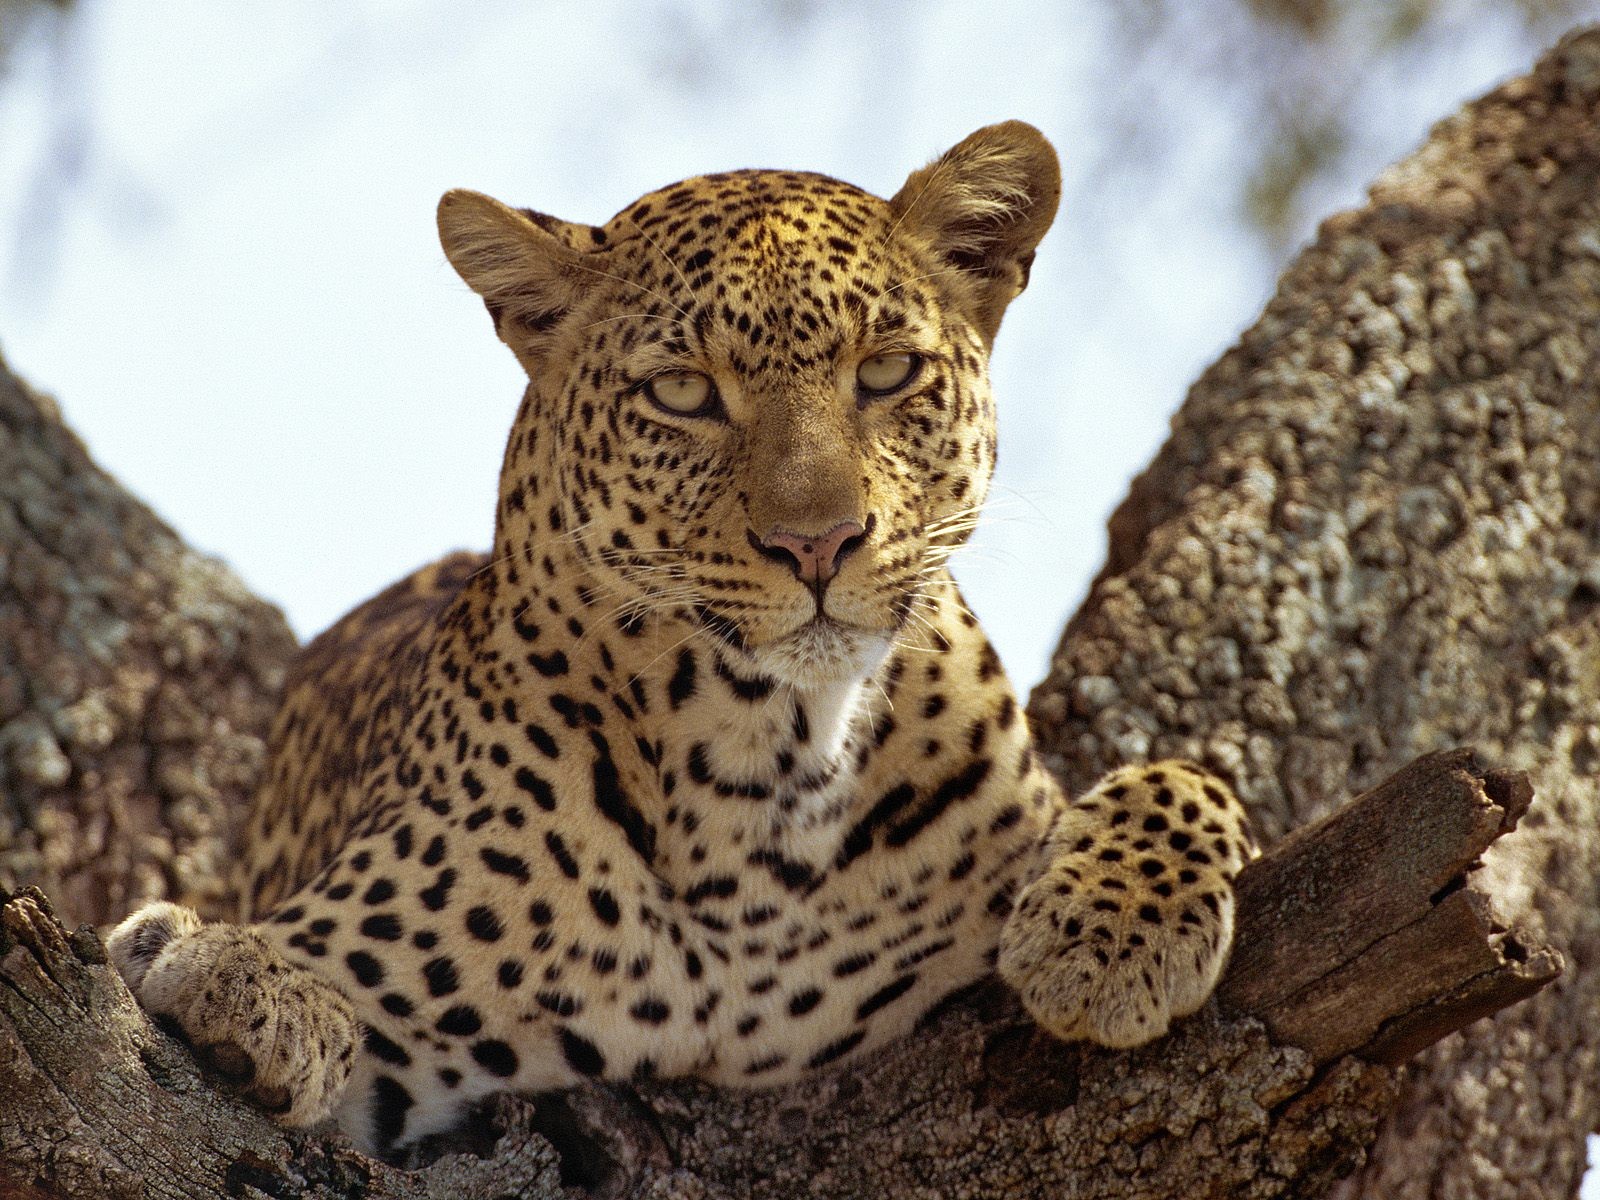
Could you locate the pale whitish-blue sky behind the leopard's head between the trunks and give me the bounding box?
[0,0,1600,1200]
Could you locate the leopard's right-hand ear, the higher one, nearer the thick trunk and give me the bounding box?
[890,122,1061,341]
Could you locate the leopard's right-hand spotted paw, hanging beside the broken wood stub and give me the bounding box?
[998,762,1254,1046]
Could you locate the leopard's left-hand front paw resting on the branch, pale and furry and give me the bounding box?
[106,902,360,1125]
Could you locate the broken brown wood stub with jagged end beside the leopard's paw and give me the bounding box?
[1218,749,1562,1066]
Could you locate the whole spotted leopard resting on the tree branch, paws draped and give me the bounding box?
[107,122,1256,1155]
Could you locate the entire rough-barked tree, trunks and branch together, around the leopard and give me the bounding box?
[0,32,1600,1200]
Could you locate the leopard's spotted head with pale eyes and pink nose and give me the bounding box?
[440,126,1054,686]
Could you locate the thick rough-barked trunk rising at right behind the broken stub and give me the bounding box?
[1029,30,1600,1200]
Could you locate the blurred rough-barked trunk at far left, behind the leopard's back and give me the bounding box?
[0,363,294,923]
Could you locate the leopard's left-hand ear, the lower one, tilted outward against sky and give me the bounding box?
[438,189,600,358]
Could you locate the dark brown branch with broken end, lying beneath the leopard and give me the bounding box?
[0,752,1560,1197]
